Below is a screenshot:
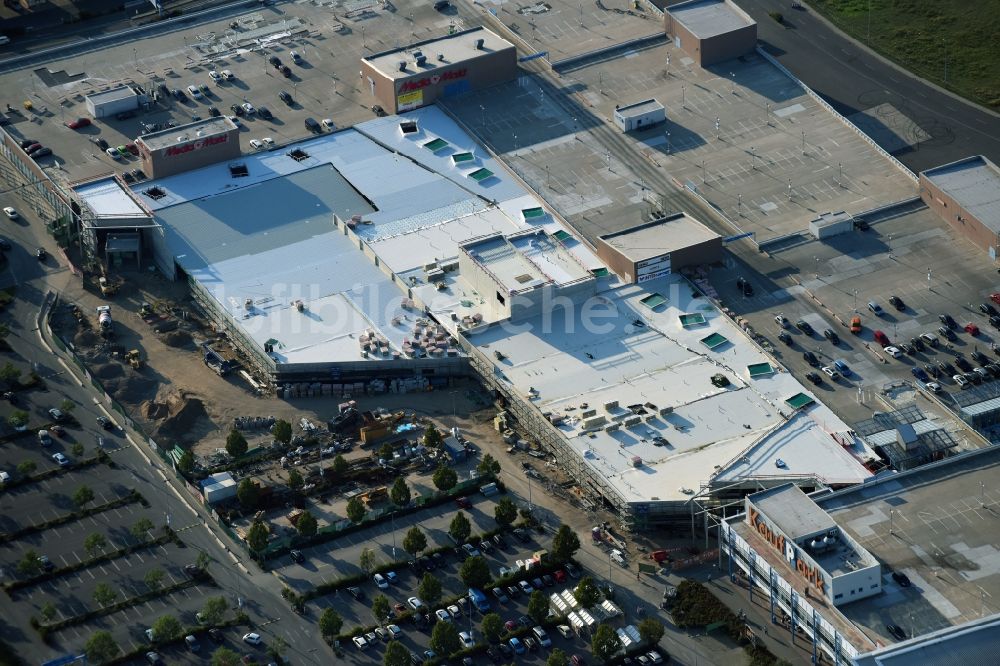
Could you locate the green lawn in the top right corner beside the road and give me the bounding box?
[809,0,1000,109]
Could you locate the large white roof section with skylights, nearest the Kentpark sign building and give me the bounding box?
[470,276,871,502]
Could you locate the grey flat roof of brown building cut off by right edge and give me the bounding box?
[922,155,1000,234]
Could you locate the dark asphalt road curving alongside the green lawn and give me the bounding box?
[739,0,1000,172]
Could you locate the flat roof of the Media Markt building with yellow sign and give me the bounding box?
[363,26,514,79]
